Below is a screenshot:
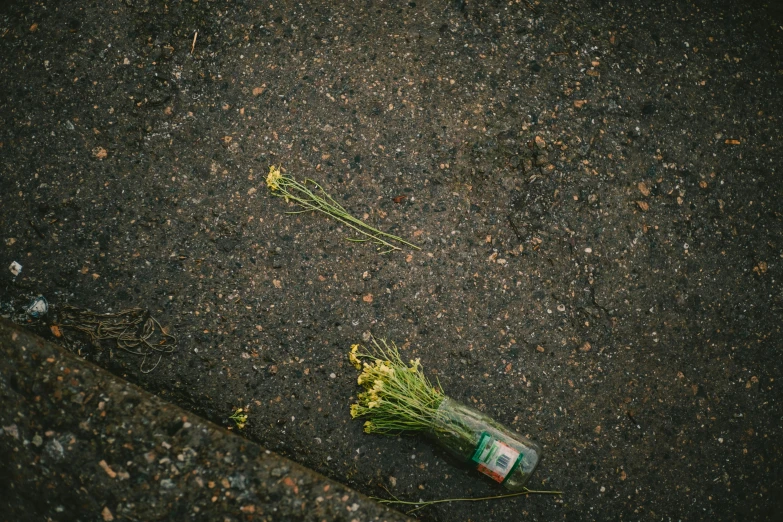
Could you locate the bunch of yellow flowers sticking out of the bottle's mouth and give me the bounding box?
[348,339,470,437]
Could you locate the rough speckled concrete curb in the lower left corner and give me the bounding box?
[0,320,408,521]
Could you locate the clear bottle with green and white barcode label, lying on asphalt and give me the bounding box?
[429,397,542,491]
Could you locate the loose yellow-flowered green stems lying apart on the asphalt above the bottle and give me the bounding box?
[266,165,421,254]
